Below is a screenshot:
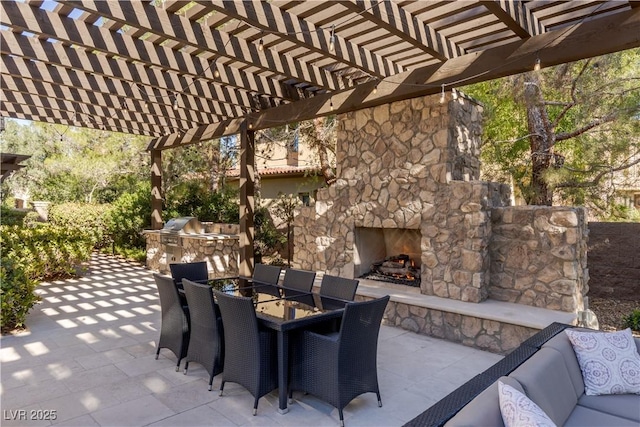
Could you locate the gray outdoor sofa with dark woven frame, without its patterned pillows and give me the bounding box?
[405,323,640,427]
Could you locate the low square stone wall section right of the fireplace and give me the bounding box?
[489,206,589,312]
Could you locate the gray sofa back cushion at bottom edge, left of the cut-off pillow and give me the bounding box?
[445,377,524,427]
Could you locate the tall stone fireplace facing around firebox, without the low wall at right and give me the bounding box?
[294,96,508,302]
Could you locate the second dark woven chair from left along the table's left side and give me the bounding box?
[182,279,224,391]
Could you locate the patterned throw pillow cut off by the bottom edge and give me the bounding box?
[498,381,556,427]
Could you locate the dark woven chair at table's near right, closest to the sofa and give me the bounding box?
[289,295,389,426]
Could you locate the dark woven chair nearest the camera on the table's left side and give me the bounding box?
[213,291,278,415]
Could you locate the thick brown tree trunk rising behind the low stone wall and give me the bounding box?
[524,72,555,206]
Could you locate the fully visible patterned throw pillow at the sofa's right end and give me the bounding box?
[565,329,640,396]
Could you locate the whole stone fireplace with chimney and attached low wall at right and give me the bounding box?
[293,91,588,312]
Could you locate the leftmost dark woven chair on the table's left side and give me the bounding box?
[153,273,189,371]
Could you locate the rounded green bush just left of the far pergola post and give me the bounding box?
[105,181,151,249]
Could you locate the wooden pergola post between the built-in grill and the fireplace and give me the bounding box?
[238,122,256,284]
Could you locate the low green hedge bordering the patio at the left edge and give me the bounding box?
[0,224,93,331]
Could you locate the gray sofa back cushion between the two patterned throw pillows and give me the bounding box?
[510,348,578,425]
